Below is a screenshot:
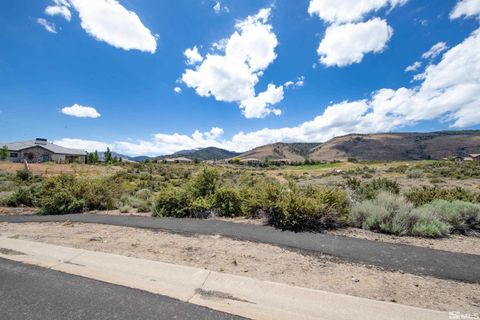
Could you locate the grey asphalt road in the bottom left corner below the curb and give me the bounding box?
[0,258,244,320]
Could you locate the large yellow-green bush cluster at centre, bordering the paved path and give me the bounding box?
[153,168,350,231]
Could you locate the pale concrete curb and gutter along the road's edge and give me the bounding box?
[0,237,448,320]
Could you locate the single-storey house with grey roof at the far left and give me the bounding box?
[0,138,87,163]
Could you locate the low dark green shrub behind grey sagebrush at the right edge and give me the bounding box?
[405,186,480,207]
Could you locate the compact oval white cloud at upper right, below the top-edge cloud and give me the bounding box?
[317,18,393,67]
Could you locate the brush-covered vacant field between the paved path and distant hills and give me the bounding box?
[0,161,480,238]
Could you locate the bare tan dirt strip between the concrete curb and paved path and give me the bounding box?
[0,222,480,312]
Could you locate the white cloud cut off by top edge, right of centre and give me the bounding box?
[308,0,408,23]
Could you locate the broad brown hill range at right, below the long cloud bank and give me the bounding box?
[234,130,480,161]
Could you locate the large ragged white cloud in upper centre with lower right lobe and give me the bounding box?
[182,8,283,118]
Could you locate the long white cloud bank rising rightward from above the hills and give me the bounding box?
[62,25,480,154]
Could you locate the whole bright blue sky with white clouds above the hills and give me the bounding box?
[0,0,480,155]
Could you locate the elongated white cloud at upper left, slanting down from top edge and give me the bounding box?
[45,0,157,53]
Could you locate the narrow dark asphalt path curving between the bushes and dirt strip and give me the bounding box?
[0,214,480,283]
